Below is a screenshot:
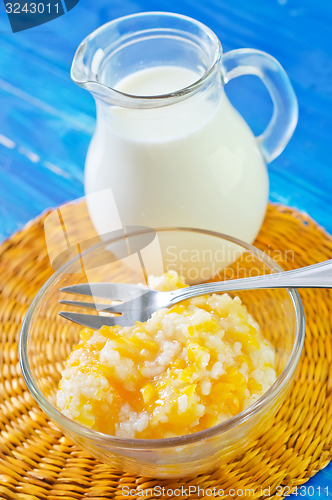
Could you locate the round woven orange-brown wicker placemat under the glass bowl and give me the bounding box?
[0,205,332,500]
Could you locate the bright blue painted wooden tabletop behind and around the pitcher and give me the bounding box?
[0,0,332,499]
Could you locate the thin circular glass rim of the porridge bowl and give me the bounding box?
[18,227,305,449]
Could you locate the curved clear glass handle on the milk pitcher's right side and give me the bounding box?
[222,49,298,163]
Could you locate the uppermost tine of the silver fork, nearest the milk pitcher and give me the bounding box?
[60,283,147,300]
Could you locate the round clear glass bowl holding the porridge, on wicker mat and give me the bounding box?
[19,228,305,478]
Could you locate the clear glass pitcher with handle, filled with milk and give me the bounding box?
[71,12,298,242]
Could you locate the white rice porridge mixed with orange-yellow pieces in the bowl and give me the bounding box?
[56,272,276,439]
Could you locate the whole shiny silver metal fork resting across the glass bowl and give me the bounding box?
[59,259,332,330]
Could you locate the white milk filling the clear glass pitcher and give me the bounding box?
[85,66,268,242]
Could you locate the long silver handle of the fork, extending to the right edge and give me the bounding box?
[172,259,332,303]
